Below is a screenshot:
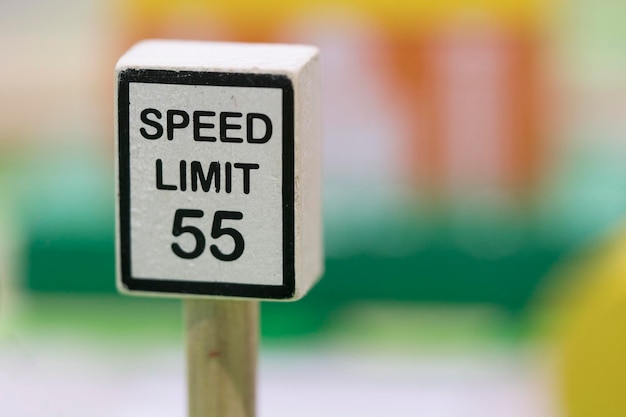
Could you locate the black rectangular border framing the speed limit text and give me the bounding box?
[117,69,295,299]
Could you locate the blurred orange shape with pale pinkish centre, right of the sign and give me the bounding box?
[381,28,542,192]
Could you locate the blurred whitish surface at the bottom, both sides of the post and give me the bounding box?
[0,337,555,417]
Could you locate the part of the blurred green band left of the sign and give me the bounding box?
[11,147,115,293]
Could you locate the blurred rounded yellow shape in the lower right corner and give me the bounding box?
[550,224,626,417]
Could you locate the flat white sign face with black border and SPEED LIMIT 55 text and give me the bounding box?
[118,69,295,298]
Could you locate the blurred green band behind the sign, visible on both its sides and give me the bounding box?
[11,149,580,337]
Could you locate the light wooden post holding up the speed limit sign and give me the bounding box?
[184,299,259,417]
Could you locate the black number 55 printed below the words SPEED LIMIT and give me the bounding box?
[172,209,245,261]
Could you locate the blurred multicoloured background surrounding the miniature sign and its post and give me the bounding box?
[0,0,626,417]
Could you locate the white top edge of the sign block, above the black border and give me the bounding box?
[115,40,319,73]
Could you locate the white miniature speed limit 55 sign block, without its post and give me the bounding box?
[116,41,322,300]
